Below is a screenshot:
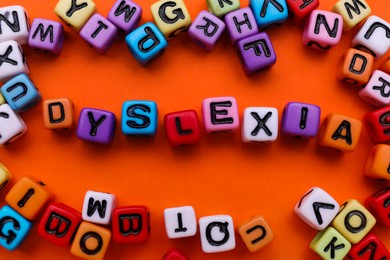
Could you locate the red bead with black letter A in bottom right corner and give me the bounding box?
[348,233,390,260]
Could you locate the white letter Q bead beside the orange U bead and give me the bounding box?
[199,215,236,253]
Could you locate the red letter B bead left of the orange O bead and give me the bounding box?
[37,203,81,246]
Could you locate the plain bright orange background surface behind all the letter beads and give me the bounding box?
[0,0,390,259]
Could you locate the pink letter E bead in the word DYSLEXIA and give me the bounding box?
[202,97,240,134]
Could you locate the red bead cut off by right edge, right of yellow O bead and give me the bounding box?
[365,187,390,227]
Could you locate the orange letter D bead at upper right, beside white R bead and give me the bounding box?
[337,48,374,86]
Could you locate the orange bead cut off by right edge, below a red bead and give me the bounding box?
[364,144,390,181]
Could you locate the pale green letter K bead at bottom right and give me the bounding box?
[310,227,351,259]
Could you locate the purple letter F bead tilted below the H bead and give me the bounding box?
[237,32,276,75]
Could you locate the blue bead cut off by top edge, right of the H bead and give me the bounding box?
[249,0,288,29]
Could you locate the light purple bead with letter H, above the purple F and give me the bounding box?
[225,7,259,45]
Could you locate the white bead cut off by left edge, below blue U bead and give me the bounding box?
[0,104,27,146]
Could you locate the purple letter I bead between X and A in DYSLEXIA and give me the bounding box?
[282,102,321,138]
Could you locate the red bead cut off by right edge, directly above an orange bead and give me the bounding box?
[364,106,390,143]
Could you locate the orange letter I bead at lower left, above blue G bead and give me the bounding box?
[5,177,53,220]
